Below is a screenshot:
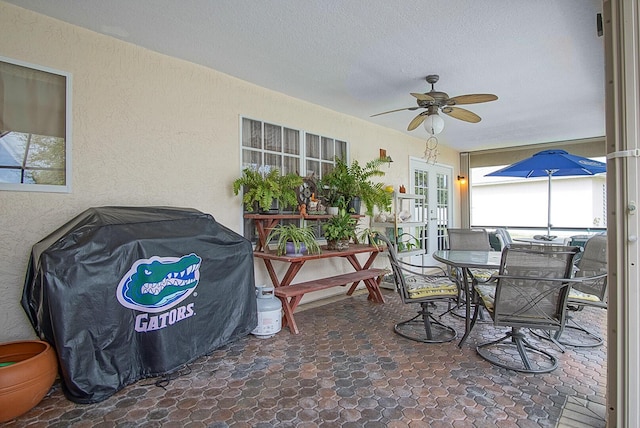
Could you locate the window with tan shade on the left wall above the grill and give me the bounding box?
[0,57,71,192]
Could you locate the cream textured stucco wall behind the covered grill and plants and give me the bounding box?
[0,1,458,341]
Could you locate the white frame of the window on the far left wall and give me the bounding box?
[0,55,73,193]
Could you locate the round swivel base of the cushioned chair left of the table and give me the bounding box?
[393,302,458,343]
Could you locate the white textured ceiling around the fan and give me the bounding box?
[5,0,605,150]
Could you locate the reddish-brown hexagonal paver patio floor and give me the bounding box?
[5,290,607,428]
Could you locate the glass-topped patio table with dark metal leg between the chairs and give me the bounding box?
[433,250,502,346]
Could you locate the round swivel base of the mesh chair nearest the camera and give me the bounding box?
[476,327,558,373]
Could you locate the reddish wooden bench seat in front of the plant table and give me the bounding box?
[274,269,388,334]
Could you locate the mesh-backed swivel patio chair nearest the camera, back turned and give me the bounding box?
[471,246,578,373]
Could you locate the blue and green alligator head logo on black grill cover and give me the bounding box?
[116,253,202,312]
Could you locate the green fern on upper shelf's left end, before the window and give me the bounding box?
[233,168,302,212]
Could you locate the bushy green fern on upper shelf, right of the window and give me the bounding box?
[322,158,391,215]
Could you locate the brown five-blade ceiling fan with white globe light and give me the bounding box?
[371,74,498,135]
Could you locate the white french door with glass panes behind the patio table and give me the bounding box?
[409,157,453,265]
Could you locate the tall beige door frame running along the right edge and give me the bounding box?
[602,0,640,428]
